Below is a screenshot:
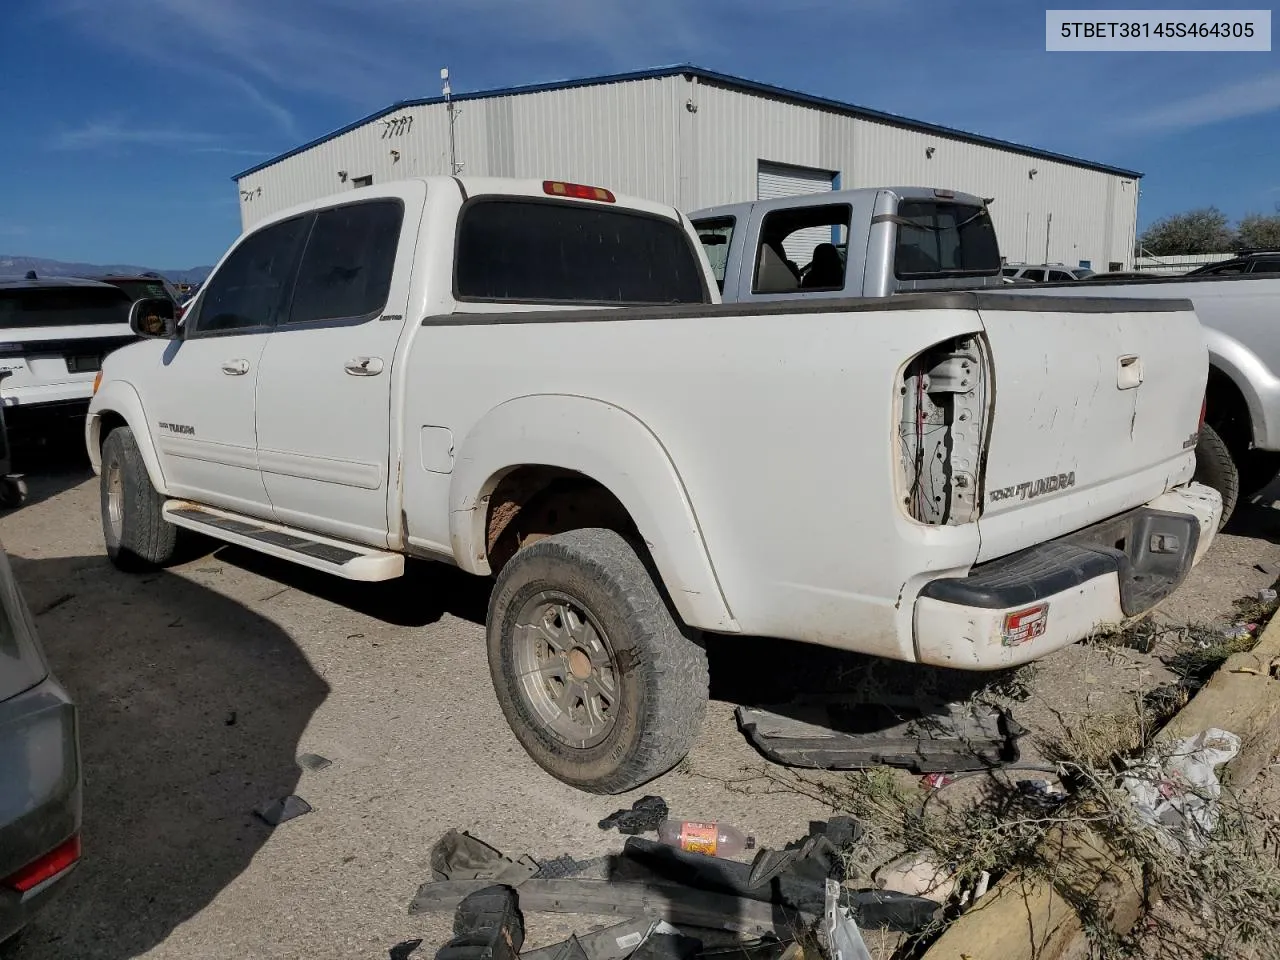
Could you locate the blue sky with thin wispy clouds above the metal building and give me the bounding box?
[0,0,1280,269]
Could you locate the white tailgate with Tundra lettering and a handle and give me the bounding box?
[978,297,1208,561]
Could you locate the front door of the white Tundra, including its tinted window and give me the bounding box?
[142,209,311,517]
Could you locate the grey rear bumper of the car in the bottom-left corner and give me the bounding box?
[0,678,81,942]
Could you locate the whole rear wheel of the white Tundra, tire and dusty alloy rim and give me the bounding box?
[488,529,708,794]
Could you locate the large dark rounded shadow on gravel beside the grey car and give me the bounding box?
[12,556,329,960]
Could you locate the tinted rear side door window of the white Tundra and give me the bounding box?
[288,200,404,324]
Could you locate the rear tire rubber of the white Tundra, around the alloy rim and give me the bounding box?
[486,529,708,794]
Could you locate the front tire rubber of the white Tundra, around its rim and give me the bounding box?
[99,426,178,572]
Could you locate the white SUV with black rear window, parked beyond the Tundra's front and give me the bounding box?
[0,278,137,442]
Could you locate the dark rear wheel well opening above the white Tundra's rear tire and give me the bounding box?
[485,466,646,573]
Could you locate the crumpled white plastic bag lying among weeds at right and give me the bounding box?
[1121,727,1240,851]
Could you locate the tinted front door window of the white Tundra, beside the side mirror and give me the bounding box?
[196,215,311,333]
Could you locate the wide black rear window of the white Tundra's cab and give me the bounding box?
[454,198,708,305]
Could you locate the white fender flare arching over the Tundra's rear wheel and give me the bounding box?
[449,394,739,632]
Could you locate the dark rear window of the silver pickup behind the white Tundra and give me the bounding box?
[893,200,998,280]
